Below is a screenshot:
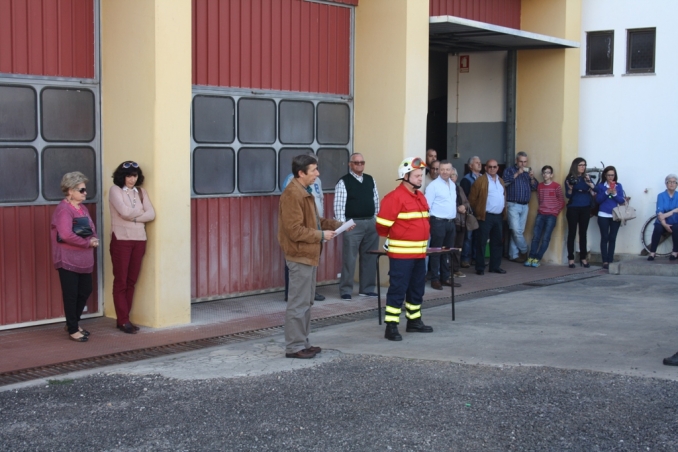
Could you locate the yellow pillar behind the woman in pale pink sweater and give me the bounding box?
[101,0,192,327]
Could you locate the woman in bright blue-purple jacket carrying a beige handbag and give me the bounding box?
[596,166,626,270]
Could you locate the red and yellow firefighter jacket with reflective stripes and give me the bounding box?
[377,184,430,259]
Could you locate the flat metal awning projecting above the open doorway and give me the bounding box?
[429,16,579,53]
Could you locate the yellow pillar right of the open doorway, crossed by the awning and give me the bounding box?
[516,0,581,263]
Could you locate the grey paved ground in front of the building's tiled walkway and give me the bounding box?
[0,276,678,451]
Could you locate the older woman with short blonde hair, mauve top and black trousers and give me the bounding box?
[50,171,99,342]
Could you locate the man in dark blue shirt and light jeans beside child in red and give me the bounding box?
[504,152,538,263]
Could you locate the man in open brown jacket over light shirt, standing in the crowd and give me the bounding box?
[468,160,506,275]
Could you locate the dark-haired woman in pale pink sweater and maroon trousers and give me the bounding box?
[108,161,155,334]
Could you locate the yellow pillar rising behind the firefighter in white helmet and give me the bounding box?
[354,0,429,284]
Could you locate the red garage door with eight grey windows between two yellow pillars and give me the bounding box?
[191,0,357,301]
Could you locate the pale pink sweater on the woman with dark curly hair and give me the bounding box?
[108,185,155,240]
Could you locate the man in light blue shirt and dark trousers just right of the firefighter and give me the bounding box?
[426,160,466,290]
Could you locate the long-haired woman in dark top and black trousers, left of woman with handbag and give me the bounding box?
[565,157,594,268]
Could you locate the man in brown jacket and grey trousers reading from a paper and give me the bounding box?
[278,154,341,359]
